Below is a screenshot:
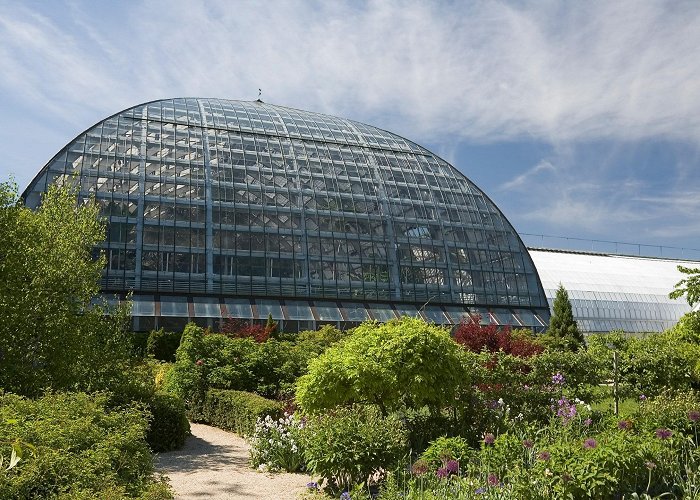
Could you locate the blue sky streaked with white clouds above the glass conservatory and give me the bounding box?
[0,0,700,258]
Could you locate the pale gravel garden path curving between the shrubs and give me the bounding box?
[156,424,311,500]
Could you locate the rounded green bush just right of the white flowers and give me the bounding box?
[303,405,408,491]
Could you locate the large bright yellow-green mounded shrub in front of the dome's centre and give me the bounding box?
[296,317,468,414]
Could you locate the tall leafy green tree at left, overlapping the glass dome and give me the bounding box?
[0,183,130,395]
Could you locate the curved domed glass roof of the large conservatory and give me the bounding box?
[24,98,548,324]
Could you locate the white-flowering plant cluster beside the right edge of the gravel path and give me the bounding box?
[249,413,304,472]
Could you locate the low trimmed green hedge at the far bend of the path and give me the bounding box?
[203,389,283,436]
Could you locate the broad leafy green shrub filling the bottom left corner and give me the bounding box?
[0,393,172,498]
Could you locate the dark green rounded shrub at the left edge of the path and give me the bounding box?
[146,392,190,452]
